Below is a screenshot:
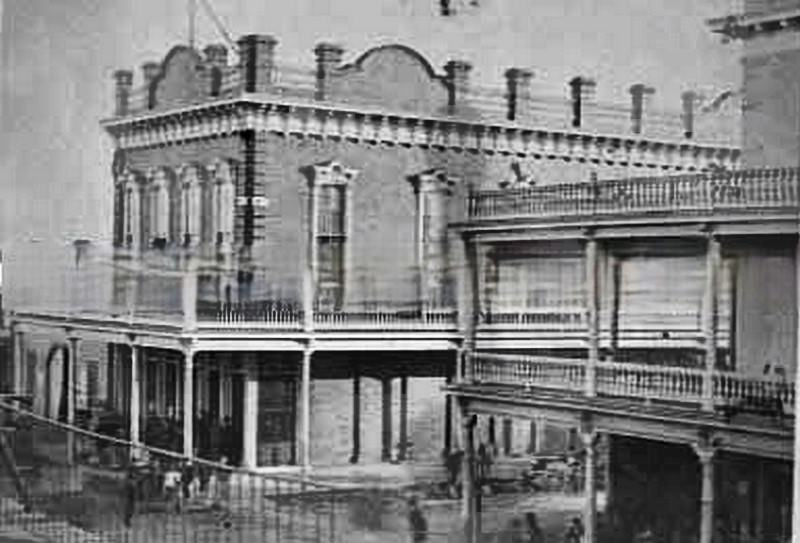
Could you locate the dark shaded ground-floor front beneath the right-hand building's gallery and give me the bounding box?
[609,436,792,543]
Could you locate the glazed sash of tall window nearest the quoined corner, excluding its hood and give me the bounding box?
[317,184,347,310]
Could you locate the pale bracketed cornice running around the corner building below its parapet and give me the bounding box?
[101,94,740,170]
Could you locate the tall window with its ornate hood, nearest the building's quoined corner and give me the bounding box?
[301,161,358,310]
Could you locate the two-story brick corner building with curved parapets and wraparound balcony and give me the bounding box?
[6,31,740,467]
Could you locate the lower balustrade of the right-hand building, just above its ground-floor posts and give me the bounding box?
[467,353,795,416]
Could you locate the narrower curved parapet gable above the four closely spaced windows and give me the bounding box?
[147,45,207,110]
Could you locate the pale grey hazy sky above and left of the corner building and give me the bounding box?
[0,0,739,246]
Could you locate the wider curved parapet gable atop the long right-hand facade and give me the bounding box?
[329,45,448,114]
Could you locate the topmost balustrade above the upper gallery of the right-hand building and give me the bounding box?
[468,168,800,220]
